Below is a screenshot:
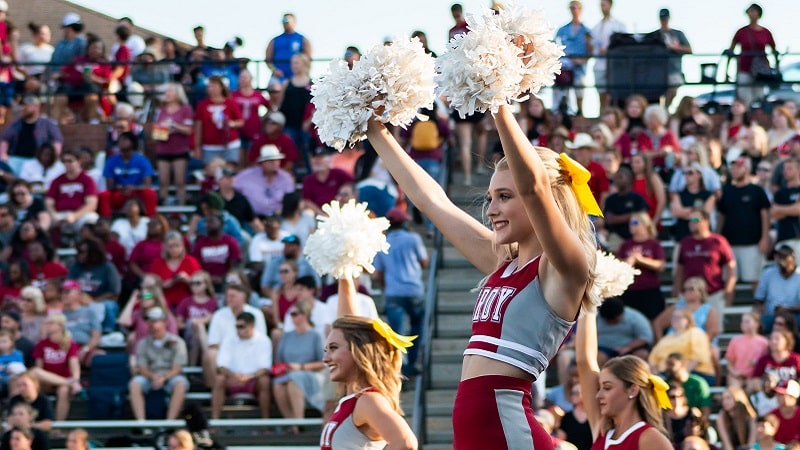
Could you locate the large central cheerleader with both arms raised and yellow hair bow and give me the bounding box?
[367,97,600,448]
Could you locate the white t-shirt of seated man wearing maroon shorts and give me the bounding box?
[217,330,272,375]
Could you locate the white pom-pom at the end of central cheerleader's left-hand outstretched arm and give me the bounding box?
[311,38,435,150]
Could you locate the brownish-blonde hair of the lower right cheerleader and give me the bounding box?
[602,355,668,436]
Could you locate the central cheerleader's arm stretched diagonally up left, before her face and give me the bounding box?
[367,120,500,274]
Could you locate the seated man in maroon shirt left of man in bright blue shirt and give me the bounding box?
[45,149,99,239]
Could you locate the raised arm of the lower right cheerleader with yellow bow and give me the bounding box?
[575,312,602,442]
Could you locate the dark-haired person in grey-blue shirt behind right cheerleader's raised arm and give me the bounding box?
[597,297,653,367]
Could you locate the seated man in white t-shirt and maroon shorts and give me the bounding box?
[211,312,272,419]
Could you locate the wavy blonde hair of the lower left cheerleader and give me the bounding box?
[332,316,403,415]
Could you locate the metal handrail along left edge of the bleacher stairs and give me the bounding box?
[411,144,450,449]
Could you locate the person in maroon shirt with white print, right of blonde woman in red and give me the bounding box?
[192,214,242,291]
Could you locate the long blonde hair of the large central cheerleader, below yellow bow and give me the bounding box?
[495,147,601,311]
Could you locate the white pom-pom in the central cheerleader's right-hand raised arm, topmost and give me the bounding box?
[436,2,564,117]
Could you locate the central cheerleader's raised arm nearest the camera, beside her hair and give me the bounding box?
[495,106,589,288]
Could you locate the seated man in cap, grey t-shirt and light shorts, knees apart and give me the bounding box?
[128,307,189,420]
